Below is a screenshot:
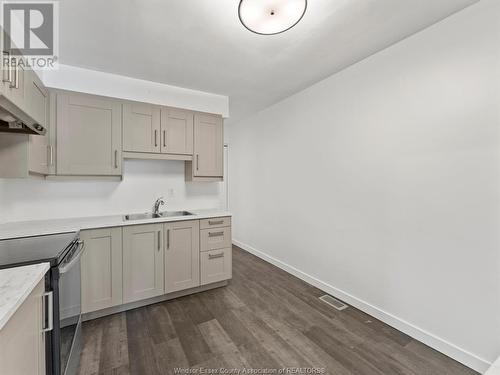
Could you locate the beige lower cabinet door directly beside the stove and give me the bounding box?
[80,228,123,313]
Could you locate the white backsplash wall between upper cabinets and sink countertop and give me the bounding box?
[0,160,225,223]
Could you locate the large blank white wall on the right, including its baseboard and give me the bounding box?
[227,0,500,371]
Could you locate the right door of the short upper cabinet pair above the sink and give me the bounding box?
[161,108,194,155]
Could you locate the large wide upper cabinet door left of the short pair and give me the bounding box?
[57,93,122,176]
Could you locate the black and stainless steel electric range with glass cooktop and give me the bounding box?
[0,232,84,375]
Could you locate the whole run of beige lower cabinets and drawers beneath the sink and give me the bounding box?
[80,217,232,314]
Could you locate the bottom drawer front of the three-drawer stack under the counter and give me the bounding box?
[200,248,232,285]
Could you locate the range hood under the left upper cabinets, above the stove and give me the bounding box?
[0,101,47,135]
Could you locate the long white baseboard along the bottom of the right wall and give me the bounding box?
[233,239,492,374]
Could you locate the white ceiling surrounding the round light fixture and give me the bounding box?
[60,0,478,121]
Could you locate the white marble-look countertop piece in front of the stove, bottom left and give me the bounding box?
[0,263,50,329]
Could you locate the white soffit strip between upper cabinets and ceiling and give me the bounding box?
[41,64,229,117]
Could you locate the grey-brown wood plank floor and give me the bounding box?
[80,247,476,375]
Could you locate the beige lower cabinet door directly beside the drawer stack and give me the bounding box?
[165,220,200,293]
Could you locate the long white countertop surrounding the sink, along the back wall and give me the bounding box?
[0,209,232,240]
